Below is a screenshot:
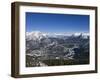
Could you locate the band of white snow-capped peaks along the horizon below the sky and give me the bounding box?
[26,31,89,40]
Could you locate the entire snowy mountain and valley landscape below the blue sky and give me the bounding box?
[26,31,89,67]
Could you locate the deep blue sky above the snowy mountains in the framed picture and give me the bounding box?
[26,12,89,33]
